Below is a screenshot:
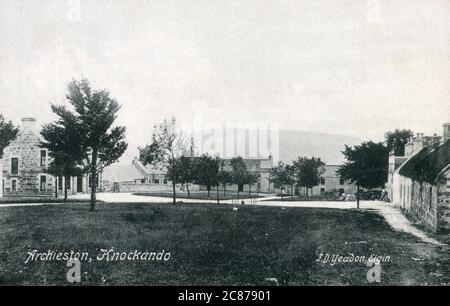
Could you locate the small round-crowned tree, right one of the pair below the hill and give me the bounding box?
[293,156,325,197]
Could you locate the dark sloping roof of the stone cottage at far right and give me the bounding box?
[399,140,450,184]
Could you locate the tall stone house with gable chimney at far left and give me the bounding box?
[0,118,94,197]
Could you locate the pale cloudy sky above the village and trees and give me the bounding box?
[0,0,450,161]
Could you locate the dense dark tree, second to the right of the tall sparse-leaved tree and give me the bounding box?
[195,154,220,198]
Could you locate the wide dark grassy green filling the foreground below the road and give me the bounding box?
[0,203,450,285]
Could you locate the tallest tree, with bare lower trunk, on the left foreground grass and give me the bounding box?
[56,79,128,211]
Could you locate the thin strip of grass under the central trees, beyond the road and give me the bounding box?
[133,190,262,200]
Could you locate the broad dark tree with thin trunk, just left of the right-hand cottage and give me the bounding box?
[337,141,389,208]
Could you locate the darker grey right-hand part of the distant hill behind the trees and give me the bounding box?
[279,130,362,165]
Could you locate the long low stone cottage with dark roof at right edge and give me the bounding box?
[391,123,450,232]
